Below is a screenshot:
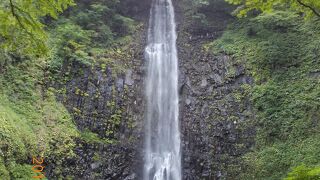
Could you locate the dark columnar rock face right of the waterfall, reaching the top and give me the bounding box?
[176,1,255,180]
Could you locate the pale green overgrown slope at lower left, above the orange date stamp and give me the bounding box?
[0,54,78,179]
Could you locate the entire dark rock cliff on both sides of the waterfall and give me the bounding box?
[47,0,255,180]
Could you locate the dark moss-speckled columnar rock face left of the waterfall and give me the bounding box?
[46,0,150,180]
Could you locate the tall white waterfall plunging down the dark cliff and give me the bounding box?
[144,0,181,180]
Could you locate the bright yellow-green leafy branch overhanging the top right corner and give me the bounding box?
[225,0,320,17]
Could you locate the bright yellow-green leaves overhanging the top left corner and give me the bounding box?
[0,0,74,55]
